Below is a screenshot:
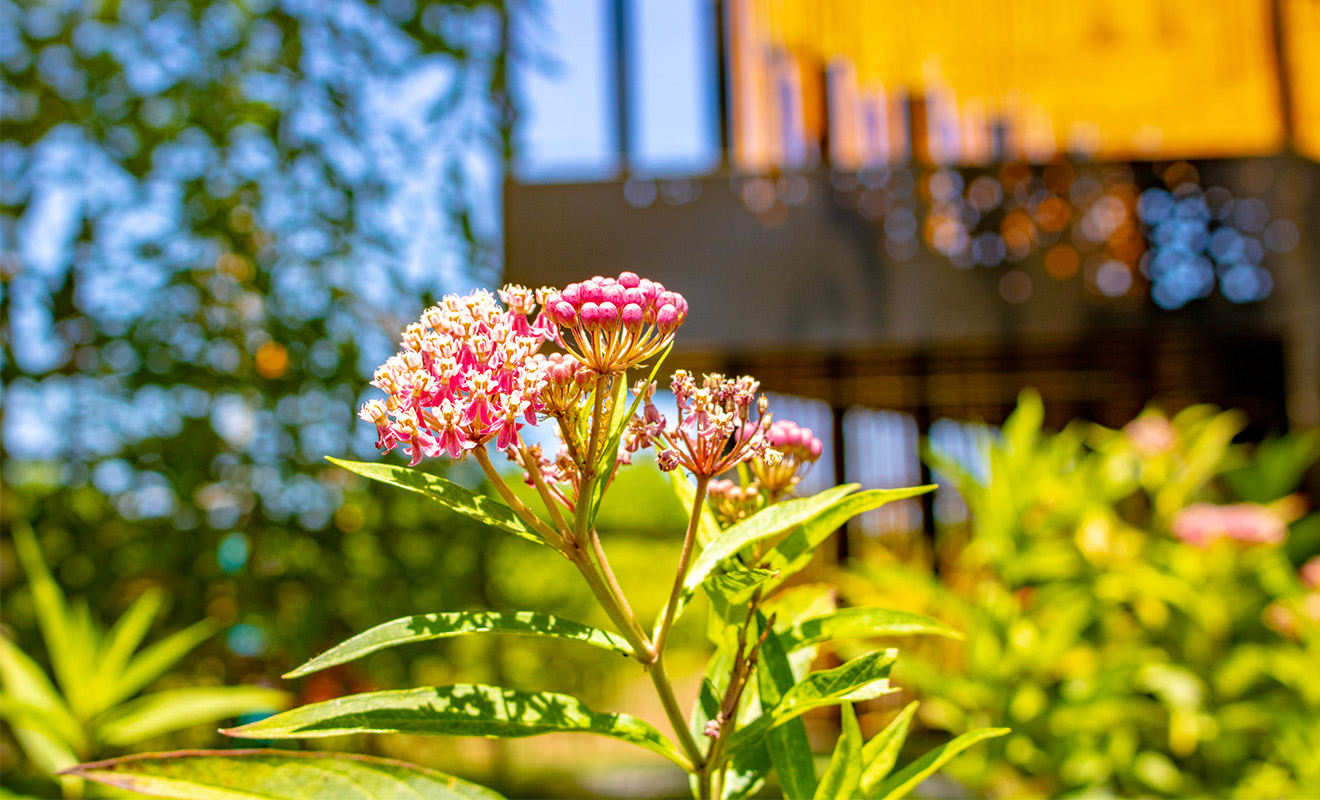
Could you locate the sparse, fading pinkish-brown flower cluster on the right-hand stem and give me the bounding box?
[627,370,780,477]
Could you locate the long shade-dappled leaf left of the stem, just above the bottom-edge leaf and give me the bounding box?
[222,684,690,770]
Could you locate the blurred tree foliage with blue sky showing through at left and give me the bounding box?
[0,0,557,785]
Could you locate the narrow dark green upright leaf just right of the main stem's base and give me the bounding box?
[755,623,816,797]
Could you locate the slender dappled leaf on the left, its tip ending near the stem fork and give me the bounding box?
[284,611,632,677]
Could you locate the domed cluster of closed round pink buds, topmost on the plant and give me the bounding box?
[545,272,688,375]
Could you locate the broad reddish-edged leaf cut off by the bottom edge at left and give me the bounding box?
[65,750,500,800]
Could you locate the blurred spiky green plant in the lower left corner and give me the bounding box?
[0,525,288,793]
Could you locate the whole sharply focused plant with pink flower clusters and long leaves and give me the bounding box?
[66,273,1006,797]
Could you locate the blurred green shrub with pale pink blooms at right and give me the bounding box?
[853,392,1320,797]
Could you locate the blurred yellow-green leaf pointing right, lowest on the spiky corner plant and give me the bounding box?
[96,686,289,747]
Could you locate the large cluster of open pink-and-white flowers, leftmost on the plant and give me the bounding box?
[359,285,554,466]
